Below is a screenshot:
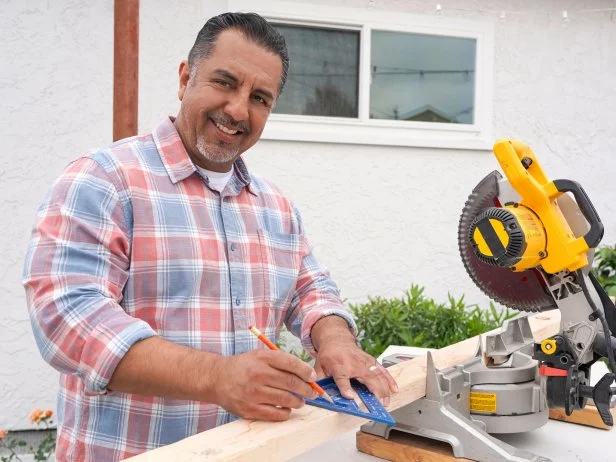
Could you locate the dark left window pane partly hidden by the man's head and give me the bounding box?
[274,24,359,117]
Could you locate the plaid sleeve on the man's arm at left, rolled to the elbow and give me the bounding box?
[23,158,156,394]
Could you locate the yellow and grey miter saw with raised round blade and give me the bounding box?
[362,139,616,461]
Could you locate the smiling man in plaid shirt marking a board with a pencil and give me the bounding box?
[24,13,396,461]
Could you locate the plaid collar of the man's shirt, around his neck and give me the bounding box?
[152,116,258,196]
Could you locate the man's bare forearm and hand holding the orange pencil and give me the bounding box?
[108,336,317,420]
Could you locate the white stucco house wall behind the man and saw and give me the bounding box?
[0,0,616,429]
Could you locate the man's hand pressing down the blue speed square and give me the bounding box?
[312,316,398,406]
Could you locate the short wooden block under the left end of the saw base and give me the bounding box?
[356,431,470,462]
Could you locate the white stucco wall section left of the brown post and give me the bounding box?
[0,1,113,429]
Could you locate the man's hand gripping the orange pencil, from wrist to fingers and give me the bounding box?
[212,350,318,421]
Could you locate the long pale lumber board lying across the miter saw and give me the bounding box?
[128,310,560,462]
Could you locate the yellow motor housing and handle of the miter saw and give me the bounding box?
[469,139,603,274]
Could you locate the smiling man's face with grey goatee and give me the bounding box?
[175,29,282,172]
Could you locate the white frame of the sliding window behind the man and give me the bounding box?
[229,0,494,150]
